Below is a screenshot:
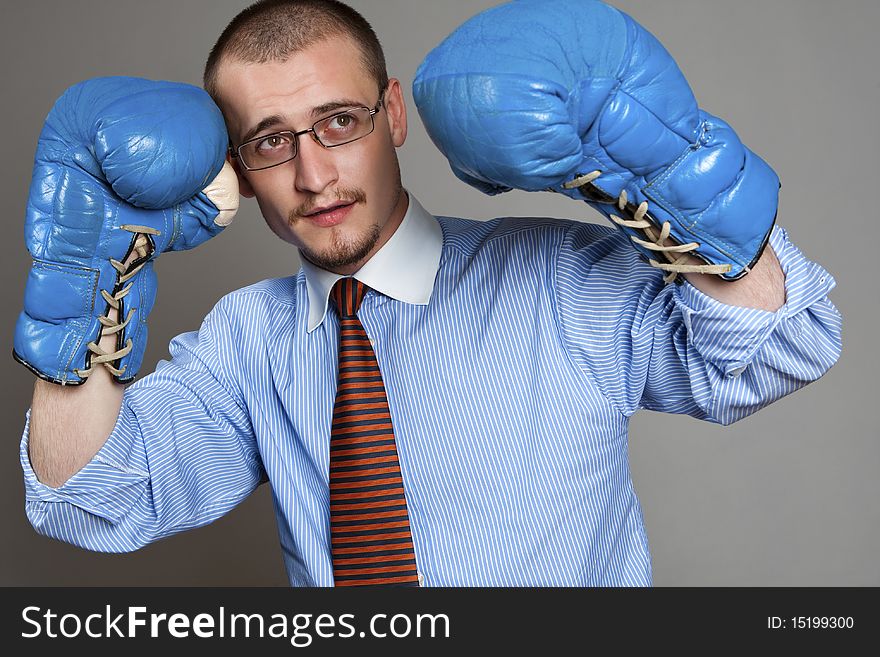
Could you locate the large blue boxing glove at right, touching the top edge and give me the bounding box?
[413,0,779,281]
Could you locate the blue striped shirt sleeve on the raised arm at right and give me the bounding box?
[556,224,842,424]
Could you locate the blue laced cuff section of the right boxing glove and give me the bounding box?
[558,111,780,282]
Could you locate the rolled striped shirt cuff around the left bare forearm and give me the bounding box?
[19,406,149,523]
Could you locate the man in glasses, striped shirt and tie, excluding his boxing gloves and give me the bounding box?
[22,2,839,585]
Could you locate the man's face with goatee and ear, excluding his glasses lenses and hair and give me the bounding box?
[217,36,407,275]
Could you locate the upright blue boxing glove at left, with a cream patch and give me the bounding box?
[13,77,238,385]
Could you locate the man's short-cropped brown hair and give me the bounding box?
[203,0,388,100]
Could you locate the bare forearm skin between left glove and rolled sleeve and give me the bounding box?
[28,318,125,488]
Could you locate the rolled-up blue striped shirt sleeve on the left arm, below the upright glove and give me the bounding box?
[20,305,265,552]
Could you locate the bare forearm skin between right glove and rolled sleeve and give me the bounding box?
[683,244,785,312]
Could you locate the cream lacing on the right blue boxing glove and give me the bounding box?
[562,171,732,283]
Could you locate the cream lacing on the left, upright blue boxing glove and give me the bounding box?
[74,224,160,379]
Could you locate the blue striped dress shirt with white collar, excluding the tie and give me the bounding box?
[21,196,841,586]
